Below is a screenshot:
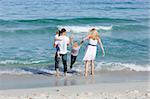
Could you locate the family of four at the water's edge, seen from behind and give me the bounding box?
[54,28,105,77]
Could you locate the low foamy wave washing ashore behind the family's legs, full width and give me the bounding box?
[0,62,150,74]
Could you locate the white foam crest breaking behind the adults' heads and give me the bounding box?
[57,26,112,33]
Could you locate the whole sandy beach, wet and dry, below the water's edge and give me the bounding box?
[0,71,150,99]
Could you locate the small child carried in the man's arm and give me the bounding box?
[54,31,61,57]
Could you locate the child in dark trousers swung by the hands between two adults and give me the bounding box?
[70,41,83,69]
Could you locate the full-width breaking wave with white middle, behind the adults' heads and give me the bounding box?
[0,25,149,34]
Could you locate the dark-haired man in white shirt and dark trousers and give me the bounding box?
[55,28,70,76]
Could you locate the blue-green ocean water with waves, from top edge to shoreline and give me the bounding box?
[0,0,150,74]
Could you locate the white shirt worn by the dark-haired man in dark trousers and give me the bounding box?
[59,36,69,54]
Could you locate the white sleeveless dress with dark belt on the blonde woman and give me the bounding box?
[83,39,98,61]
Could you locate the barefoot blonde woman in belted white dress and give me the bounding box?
[83,28,105,77]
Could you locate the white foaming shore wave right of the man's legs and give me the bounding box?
[73,62,150,72]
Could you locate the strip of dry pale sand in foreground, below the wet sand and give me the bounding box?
[0,82,150,99]
